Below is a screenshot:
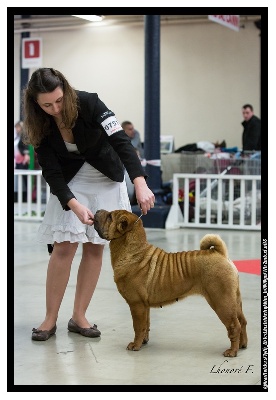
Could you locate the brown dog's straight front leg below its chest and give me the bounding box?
[127,303,150,351]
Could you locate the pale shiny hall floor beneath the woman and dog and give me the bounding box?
[14,222,262,391]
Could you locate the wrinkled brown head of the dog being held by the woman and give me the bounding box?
[94,210,143,240]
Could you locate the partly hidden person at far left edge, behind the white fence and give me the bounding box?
[14,121,30,202]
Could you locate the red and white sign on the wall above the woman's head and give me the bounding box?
[22,38,42,68]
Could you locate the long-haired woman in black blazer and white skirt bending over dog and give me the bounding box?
[24,68,155,340]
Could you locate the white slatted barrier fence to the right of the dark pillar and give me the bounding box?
[165,174,261,230]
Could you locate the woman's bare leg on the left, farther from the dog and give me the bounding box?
[35,242,78,331]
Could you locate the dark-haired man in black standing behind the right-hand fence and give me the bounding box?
[241,104,261,152]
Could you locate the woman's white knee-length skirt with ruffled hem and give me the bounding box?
[37,162,131,244]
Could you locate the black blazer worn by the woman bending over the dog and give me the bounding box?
[35,91,147,210]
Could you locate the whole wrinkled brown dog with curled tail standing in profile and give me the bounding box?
[94,210,247,357]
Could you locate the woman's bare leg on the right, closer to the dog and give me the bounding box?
[72,243,104,328]
